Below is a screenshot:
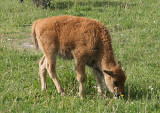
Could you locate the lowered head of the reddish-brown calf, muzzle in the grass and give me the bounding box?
[104,62,126,97]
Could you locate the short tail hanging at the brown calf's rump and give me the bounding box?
[31,21,39,49]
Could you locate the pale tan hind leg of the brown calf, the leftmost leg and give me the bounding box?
[39,56,47,91]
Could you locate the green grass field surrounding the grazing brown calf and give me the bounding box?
[0,0,160,113]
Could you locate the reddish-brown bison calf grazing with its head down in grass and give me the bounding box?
[32,15,126,97]
